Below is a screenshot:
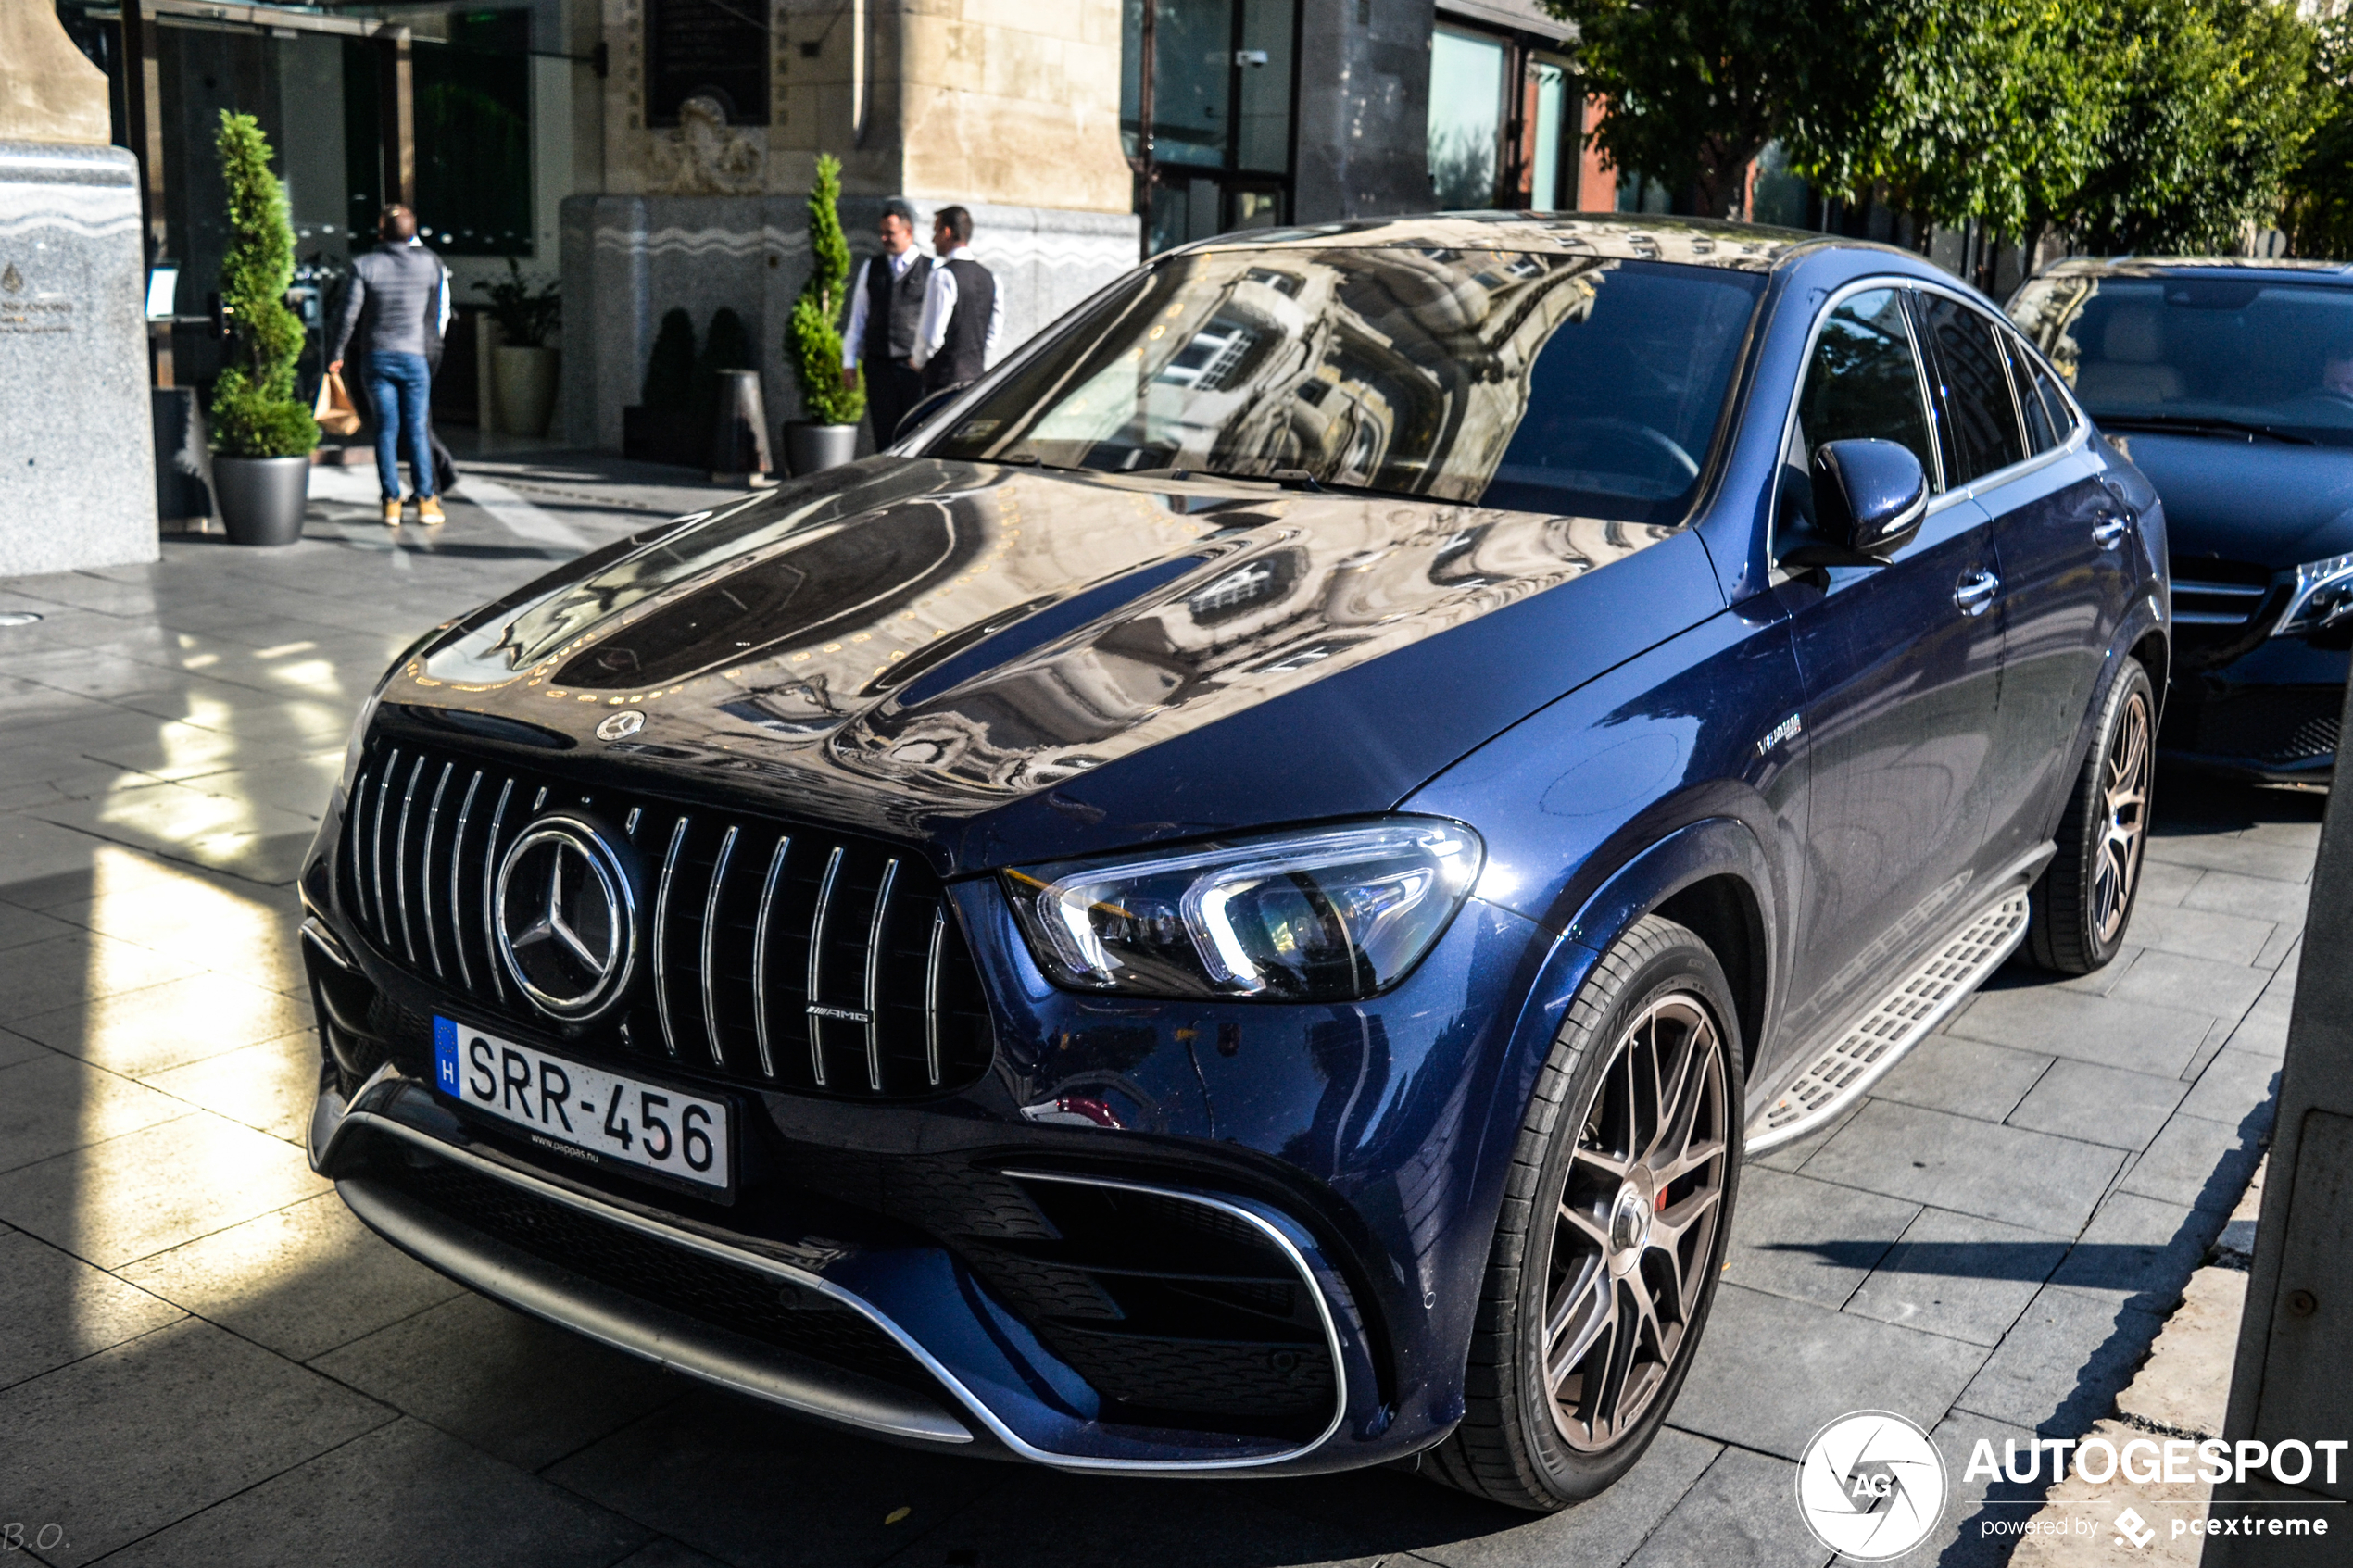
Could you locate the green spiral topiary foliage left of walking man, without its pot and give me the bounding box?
[212,108,318,458]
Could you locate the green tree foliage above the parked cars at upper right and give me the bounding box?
[1548,0,2324,252]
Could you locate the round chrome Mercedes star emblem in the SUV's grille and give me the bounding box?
[494,816,637,1021]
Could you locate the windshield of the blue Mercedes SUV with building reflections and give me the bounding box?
[929,247,1765,524]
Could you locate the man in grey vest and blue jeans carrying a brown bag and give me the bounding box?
[327,202,449,529]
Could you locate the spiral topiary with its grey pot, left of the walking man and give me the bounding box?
[212,108,318,546]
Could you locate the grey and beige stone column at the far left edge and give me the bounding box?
[0,0,157,576]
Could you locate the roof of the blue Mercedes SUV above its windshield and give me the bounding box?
[1169,211,1922,272]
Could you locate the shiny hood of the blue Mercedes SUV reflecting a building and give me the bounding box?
[384,458,1722,872]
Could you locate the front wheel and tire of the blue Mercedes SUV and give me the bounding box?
[1421,917,1743,1514]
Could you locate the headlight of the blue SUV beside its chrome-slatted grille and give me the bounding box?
[1005,816,1485,1001]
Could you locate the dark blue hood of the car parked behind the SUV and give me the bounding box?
[2110,430,2353,569]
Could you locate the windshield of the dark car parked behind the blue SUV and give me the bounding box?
[2009,272,2353,445]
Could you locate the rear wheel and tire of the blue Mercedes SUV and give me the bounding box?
[2026,659,2158,975]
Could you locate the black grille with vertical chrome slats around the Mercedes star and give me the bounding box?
[341,738,993,1098]
